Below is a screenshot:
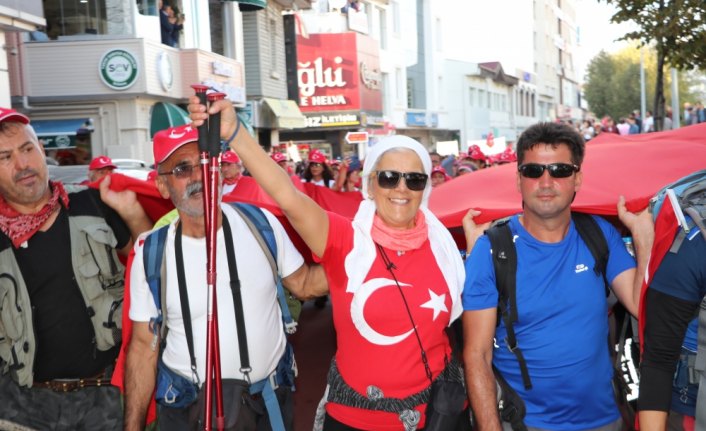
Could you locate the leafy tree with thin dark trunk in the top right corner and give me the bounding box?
[599,0,706,130]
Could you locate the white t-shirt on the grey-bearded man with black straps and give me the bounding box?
[130,204,304,383]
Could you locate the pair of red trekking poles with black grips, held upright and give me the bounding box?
[204,93,225,431]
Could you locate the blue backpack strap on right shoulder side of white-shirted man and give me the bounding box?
[231,202,297,334]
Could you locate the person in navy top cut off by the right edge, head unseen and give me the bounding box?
[638,228,706,431]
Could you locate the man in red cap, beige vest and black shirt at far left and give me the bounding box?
[0,108,151,430]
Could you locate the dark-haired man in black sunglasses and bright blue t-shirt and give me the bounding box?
[463,123,654,431]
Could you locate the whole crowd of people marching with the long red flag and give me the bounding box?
[0,102,706,431]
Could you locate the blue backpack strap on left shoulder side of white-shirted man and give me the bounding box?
[142,225,169,340]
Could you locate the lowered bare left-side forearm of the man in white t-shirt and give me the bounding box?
[125,322,159,431]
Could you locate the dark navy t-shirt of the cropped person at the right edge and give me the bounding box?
[650,227,706,352]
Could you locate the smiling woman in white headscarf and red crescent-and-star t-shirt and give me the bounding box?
[189,98,467,431]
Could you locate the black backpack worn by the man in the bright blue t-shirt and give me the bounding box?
[485,212,634,430]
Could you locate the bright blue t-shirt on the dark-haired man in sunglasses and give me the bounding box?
[463,216,635,430]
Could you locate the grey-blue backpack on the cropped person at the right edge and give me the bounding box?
[650,169,706,253]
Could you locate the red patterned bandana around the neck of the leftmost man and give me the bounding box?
[0,181,69,248]
